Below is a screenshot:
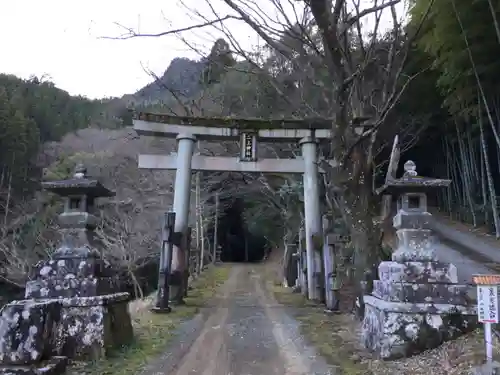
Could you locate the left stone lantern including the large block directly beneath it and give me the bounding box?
[25,165,132,358]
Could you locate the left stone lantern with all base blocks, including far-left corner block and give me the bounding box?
[0,166,133,374]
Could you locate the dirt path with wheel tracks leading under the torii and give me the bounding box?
[166,265,333,375]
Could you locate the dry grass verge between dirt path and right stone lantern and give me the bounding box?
[268,280,500,375]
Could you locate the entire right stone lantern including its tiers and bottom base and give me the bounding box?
[361,161,477,359]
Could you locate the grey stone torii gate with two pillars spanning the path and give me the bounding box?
[133,112,334,302]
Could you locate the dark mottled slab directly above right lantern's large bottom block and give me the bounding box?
[372,280,469,305]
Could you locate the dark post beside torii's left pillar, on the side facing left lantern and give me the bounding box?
[152,212,175,313]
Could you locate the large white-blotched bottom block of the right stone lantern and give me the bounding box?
[361,296,477,359]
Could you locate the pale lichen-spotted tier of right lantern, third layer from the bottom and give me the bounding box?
[378,262,458,284]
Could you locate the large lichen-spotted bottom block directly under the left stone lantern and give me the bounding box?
[57,293,133,359]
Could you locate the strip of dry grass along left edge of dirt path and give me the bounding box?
[70,265,229,375]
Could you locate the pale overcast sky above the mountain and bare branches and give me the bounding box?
[0,0,404,98]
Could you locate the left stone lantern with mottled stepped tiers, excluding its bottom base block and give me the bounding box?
[26,164,119,298]
